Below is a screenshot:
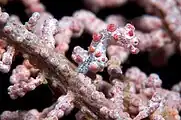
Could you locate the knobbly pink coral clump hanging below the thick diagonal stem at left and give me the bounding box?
[8,61,45,99]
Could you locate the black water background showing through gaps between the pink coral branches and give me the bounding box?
[0,0,181,119]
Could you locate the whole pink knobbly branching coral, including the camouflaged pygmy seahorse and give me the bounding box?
[0,0,181,120]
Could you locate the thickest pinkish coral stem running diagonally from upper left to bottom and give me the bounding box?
[0,9,122,119]
